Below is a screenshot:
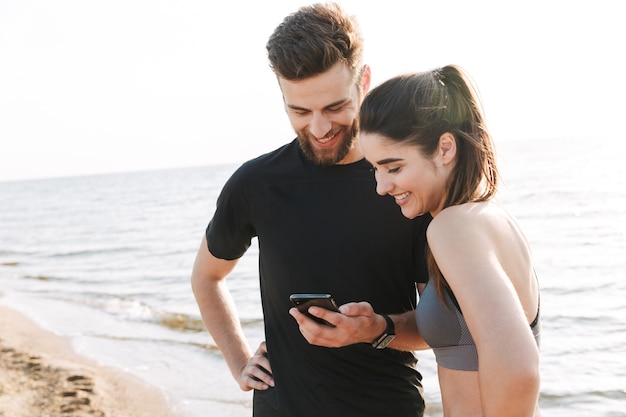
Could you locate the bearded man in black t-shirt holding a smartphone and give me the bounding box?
[192,3,430,417]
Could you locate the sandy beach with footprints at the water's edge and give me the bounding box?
[0,307,181,417]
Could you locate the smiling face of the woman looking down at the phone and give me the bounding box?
[359,132,449,219]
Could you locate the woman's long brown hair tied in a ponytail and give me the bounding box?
[360,65,499,299]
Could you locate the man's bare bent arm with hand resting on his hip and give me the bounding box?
[191,237,274,391]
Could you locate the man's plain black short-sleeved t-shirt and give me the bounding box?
[206,140,430,417]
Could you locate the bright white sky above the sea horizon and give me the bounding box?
[0,0,626,181]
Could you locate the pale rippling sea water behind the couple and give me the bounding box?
[0,138,626,417]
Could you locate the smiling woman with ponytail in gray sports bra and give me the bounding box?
[359,65,540,417]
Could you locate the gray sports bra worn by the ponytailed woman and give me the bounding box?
[415,285,541,371]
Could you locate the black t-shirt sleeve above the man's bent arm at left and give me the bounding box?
[206,166,256,260]
